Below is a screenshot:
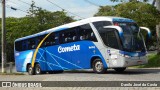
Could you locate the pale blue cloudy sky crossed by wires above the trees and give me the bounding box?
[0,0,118,19]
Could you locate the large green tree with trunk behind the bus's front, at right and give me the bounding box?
[95,2,160,47]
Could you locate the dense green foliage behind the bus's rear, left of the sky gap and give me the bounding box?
[0,2,74,61]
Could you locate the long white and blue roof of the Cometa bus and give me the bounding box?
[15,16,134,41]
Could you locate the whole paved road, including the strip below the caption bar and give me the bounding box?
[0,68,160,90]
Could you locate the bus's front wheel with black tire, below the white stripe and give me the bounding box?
[92,59,107,74]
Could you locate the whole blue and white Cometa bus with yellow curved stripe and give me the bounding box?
[14,17,150,75]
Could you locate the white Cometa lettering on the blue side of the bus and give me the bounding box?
[58,44,80,53]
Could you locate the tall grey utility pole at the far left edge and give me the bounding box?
[1,0,6,73]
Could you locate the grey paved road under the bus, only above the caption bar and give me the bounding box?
[0,69,160,81]
